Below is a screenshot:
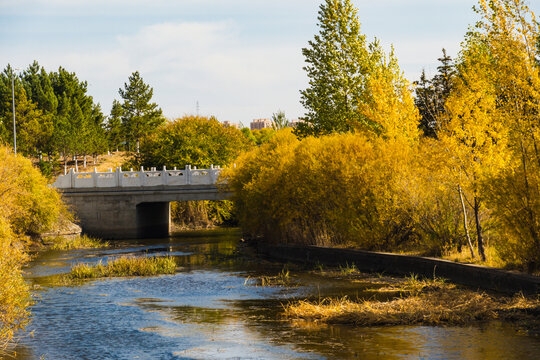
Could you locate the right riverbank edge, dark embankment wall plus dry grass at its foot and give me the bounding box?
[257,244,540,335]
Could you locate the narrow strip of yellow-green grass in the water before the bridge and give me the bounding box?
[68,256,176,280]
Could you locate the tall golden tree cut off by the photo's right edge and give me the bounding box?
[477,0,540,270]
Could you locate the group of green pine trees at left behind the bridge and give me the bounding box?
[0,62,164,172]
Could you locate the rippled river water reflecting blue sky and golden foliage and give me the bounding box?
[11,231,540,359]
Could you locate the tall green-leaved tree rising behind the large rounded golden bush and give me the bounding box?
[296,0,378,136]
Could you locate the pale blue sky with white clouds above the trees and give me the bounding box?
[0,0,540,125]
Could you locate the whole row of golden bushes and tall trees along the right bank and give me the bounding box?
[227,0,540,271]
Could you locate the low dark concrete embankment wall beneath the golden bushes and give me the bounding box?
[258,243,540,294]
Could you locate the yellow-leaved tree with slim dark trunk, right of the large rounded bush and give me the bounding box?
[439,38,508,261]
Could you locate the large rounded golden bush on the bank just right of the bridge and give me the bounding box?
[225,130,463,254]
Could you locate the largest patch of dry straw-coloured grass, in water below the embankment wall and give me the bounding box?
[284,278,540,326]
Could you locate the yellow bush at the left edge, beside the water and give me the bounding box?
[0,145,67,348]
